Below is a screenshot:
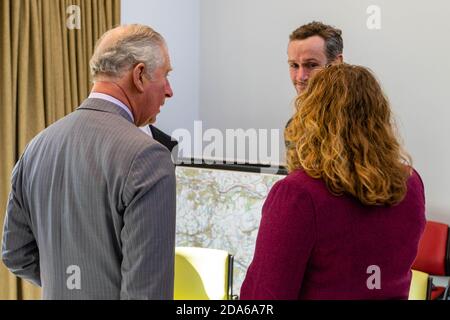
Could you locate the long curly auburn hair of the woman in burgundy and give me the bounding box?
[285,64,411,205]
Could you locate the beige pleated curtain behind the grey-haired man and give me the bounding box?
[0,0,120,299]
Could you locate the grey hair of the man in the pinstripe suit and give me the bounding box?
[89,24,166,80]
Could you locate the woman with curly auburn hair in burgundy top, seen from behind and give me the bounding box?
[241,64,425,299]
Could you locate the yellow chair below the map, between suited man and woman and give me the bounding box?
[174,247,233,300]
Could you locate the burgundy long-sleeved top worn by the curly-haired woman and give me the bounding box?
[240,170,425,300]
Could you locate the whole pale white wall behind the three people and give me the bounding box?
[122,0,450,223]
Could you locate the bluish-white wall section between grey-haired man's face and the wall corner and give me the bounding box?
[121,0,200,133]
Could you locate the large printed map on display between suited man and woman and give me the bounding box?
[176,167,284,294]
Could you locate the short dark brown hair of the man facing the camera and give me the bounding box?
[289,21,344,62]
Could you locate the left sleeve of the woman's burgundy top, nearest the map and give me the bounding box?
[240,178,316,300]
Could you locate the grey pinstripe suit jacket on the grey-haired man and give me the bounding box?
[2,99,176,299]
